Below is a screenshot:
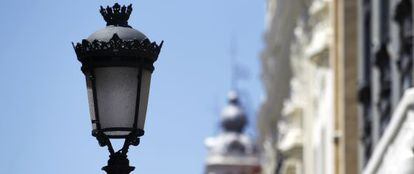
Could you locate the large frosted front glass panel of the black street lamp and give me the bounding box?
[95,67,138,136]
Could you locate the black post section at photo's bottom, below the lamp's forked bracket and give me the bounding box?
[102,152,135,174]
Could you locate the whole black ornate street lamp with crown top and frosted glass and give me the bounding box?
[73,3,163,174]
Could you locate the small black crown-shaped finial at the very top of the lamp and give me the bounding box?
[99,3,132,27]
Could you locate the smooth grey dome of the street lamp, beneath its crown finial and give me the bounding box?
[87,25,147,42]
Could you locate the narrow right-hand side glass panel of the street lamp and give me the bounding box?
[137,69,151,130]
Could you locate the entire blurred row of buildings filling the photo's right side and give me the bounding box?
[258,0,414,174]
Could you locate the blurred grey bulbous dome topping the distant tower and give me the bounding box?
[221,91,247,132]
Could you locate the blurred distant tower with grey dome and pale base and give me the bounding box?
[205,91,260,174]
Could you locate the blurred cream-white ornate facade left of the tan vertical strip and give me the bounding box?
[259,0,335,174]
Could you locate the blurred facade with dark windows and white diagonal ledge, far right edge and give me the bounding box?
[359,0,414,174]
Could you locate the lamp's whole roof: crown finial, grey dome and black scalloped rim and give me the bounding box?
[73,3,163,68]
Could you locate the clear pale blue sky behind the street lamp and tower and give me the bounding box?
[0,0,265,174]
